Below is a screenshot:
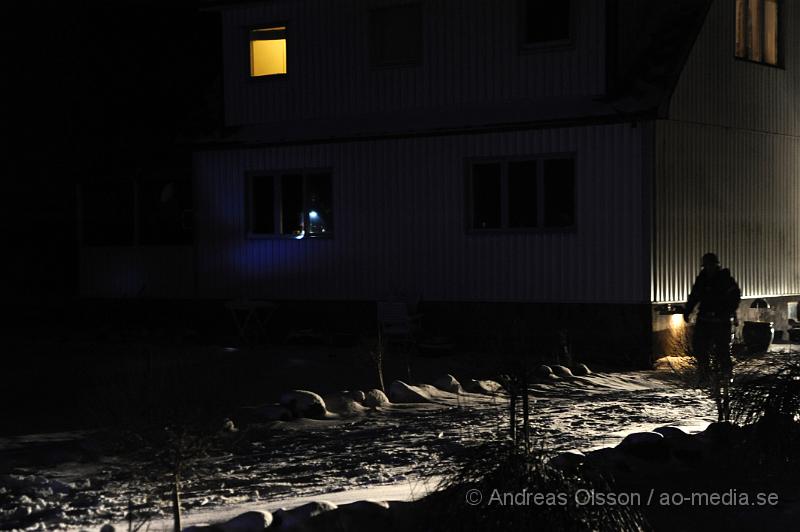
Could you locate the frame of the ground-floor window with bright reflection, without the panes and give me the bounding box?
[244,167,337,240]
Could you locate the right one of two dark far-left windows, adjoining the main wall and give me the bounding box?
[138,180,193,245]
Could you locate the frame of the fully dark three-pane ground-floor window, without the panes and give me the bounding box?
[464,155,580,235]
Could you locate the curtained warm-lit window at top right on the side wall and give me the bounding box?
[736,0,780,65]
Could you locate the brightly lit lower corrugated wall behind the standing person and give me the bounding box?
[652,121,800,301]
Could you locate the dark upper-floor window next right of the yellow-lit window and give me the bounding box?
[369,4,422,66]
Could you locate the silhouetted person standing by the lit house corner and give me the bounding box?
[683,253,742,379]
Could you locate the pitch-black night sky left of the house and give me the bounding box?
[2,0,222,298]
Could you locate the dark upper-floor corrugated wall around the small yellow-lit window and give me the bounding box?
[223,0,605,129]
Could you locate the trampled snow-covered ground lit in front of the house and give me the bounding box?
[0,371,716,530]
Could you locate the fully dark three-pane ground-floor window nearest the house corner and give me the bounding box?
[467,157,576,230]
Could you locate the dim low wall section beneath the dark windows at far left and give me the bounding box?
[80,246,195,298]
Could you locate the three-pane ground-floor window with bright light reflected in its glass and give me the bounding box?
[248,171,333,238]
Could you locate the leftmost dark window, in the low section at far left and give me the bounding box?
[81,181,135,246]
